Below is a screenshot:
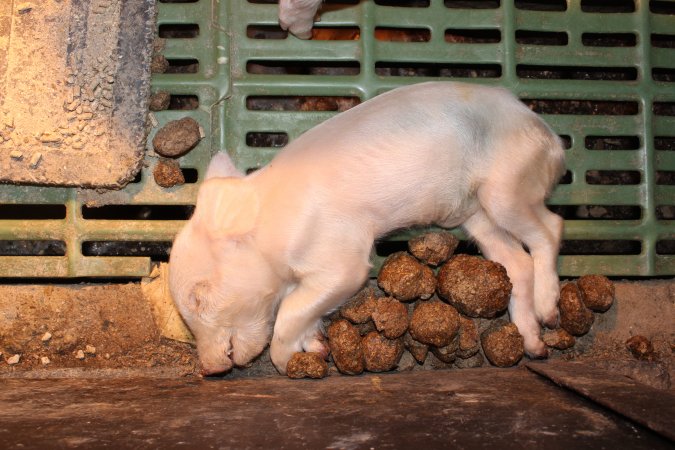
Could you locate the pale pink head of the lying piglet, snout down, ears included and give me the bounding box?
[169,156,279,375]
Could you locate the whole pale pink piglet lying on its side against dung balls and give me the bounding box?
[170,82,564,374]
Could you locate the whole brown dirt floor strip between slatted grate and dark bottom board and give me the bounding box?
[0,280,675,389]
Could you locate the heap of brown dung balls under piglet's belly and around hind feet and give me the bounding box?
[286,232,614,375]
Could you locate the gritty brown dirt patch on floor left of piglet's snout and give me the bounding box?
[0,283,196,376]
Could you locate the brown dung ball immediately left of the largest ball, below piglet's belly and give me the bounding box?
[377,252,436,302]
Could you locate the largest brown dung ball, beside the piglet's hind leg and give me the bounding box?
[438,255,512,319]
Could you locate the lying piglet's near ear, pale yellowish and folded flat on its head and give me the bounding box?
[193,178,260,239]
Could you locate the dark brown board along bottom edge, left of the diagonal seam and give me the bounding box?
[0,367,672,449]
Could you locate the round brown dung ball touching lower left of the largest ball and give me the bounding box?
[409,300,459,347]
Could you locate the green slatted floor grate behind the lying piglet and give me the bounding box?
[0,0,675,277]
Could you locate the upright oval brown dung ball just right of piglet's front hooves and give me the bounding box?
[327,319,365,375]
